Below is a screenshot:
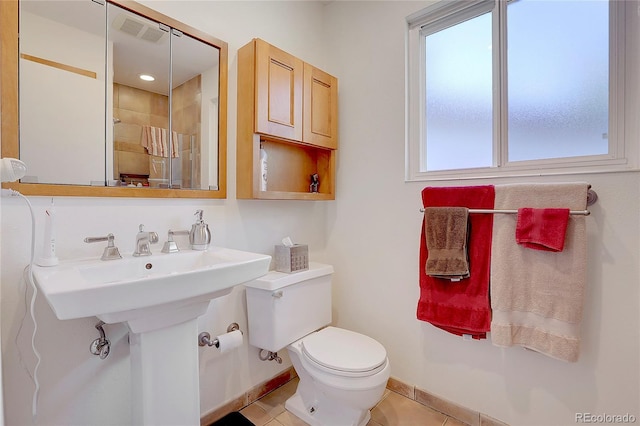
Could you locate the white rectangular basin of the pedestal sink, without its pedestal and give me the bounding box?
[33,247,271,331]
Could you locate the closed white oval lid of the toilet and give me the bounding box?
[302,327,387,373]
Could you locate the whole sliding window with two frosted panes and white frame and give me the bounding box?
[407,0,638,180]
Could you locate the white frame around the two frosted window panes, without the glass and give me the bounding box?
[405,0,640,181]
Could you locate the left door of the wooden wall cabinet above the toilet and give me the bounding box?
[255,39,304,141]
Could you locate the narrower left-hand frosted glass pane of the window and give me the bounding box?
[423,13,493,171]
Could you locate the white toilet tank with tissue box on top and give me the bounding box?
[244,262,333,352]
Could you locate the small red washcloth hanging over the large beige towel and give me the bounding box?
[516,207,569,251]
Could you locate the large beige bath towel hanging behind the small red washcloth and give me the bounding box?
[491,183,588,362]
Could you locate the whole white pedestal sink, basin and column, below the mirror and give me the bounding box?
[33,247,271,426]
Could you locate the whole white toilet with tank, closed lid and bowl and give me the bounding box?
[245,262,390,426]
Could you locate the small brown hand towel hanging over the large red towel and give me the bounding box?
[424,207,469,281]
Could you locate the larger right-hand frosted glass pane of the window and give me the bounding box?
[507,0,609,161]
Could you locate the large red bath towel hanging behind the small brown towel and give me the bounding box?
[417,185,495,339]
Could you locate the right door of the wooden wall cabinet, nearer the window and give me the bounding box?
[302,63,338,149]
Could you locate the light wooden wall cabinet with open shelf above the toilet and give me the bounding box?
[236,39,338,200]
